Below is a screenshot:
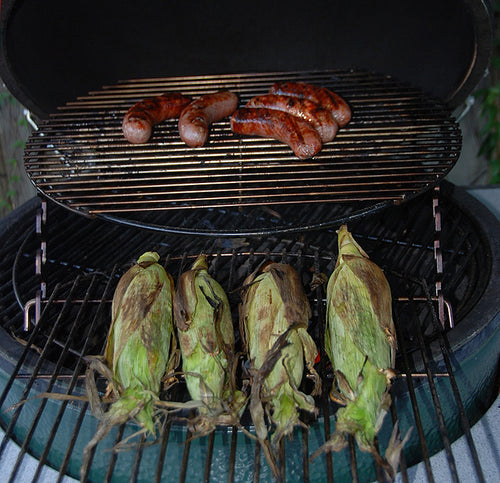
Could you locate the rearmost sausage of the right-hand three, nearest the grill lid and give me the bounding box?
[269,82,351,127]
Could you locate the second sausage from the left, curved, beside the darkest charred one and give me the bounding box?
[179,91,238,148]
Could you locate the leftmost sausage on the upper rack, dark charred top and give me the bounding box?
[122,92,191,144]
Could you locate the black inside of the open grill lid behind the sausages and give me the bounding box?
[0,0,492,118]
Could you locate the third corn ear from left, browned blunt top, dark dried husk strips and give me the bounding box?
[240,262,320,474]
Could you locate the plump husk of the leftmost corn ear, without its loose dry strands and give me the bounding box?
[104,252,174,433]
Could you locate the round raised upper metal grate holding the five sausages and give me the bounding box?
[25,71,461,235]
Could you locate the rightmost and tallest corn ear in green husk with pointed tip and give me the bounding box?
[317,225,409,478]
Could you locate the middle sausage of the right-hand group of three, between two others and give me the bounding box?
[246,94,339,143]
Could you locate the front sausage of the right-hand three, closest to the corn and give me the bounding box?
[231,107,322,159]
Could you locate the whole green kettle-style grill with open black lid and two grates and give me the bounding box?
[0,0,500,481]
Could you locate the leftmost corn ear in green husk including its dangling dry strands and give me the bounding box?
[81,252,176,477]
